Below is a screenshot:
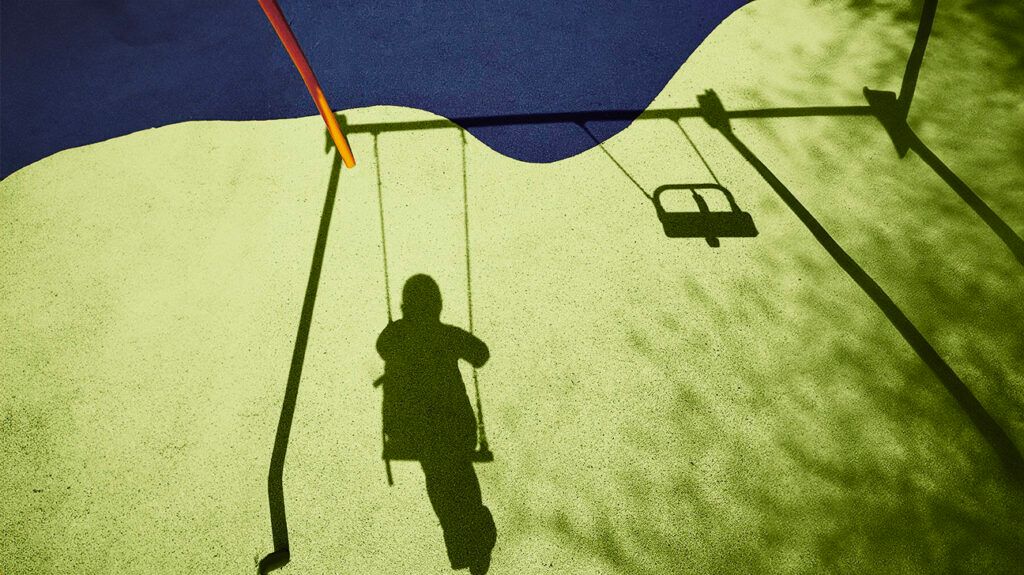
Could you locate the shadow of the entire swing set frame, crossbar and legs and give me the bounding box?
[257,0,1024,574]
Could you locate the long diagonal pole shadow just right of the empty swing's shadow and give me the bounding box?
[709,120,1024,481]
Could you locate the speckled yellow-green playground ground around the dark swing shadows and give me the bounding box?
[0,0,1024,575]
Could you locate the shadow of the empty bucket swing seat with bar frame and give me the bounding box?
[651,183,758,242]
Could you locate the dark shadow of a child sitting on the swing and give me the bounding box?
[375,274,497,575]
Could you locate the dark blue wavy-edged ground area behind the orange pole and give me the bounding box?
[0,0,746,177]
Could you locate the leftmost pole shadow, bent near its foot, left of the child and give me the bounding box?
[258,150,341,574]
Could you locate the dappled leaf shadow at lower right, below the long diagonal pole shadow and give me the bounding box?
[546,270,1024,574]
